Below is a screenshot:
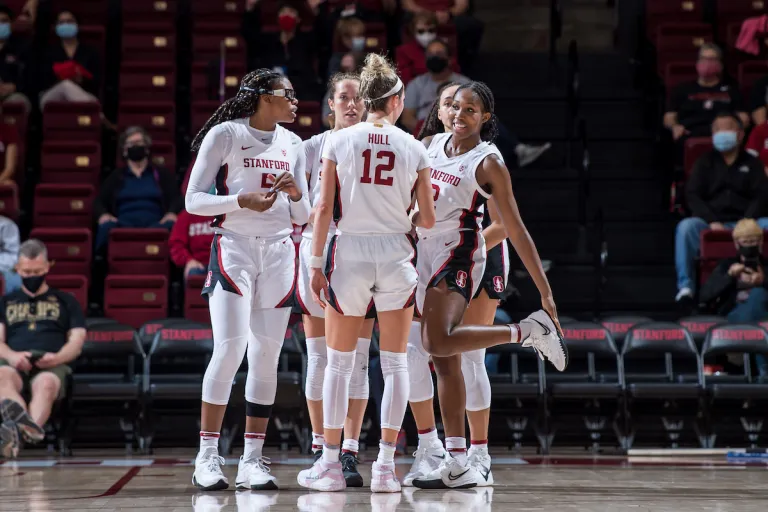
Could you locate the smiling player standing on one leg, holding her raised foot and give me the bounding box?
[411,82,568,489]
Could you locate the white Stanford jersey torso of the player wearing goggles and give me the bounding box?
[212,118,304,237]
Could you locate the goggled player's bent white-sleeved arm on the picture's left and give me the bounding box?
[184,126,240,216]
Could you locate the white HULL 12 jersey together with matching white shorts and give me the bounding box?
[322,123,429,316]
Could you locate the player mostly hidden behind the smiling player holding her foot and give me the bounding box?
[403,82,509,486]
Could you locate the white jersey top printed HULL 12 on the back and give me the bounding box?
[323,123,429,235]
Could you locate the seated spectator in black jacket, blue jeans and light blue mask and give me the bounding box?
[675,113,768,309]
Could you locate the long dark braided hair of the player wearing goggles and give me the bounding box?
[192,68,283,151]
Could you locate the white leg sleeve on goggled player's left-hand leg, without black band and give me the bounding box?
[203,286,251,405]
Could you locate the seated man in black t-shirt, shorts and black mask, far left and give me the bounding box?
[0,239,85,458]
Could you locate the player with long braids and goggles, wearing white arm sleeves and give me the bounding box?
[186,69,310,490]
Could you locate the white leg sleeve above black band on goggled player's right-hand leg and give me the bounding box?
[245,308,291,405]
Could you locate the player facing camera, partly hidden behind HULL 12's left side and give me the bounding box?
[296,73,376,487]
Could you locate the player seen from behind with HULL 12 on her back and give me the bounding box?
[298,54,434,492]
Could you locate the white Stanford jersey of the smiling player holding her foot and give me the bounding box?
[417,133,501,238]
